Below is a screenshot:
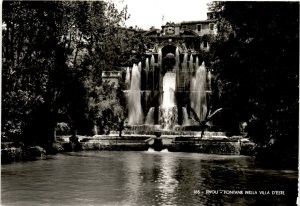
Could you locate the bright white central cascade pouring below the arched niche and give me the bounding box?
[159,72,178,130]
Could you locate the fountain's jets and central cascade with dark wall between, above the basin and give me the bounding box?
[126,47,211,133]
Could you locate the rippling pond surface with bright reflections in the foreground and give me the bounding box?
[1,151,298,206]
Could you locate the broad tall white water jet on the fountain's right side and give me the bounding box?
[190,62,207,121]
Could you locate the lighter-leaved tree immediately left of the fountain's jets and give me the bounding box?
[60,2,144,133]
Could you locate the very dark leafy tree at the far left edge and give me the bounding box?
[2,1,66,144]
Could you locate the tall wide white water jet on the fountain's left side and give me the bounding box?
[128,64,144,125]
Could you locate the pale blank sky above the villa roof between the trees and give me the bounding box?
[115,0,211,30]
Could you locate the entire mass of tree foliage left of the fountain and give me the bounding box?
[1,1,145,144]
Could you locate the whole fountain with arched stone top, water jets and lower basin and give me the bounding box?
[87,22,253,154]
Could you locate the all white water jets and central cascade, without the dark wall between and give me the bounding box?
[126,48,211,130]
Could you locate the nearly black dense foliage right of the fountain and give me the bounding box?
[210,2,299,164]
